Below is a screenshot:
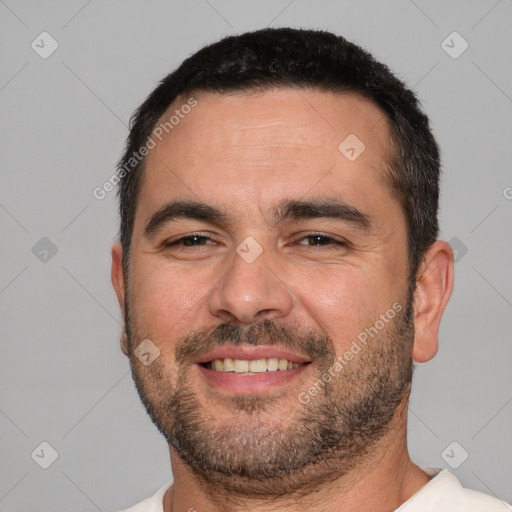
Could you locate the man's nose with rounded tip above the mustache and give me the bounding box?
[208,245,293,324]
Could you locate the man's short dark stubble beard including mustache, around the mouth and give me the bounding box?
[127,303,414,498]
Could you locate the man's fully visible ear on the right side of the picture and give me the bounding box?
[412,240,453,363]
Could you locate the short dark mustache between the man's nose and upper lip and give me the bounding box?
[176,319,335,364]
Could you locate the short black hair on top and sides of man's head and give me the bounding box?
[117,28,440,283]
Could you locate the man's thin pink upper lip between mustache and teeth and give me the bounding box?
[194,345,311,364]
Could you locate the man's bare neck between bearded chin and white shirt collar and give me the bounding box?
[164,404,429,512]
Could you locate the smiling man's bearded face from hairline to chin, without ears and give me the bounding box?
[122,89,413,492]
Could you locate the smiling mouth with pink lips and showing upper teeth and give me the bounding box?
[196,346,312,394]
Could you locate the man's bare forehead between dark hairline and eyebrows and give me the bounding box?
[140,88,391,218]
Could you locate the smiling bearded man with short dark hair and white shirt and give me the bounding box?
[112,29,508,512]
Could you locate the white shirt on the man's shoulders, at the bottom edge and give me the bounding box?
[119,468,512,512]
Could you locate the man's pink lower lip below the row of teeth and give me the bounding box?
[196,364,311,394]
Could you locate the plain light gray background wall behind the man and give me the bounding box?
[0,0,512,512]
